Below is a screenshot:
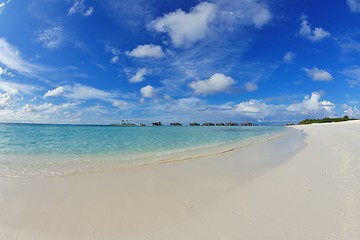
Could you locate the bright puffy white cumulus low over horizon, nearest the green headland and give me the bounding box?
[287,92,335,116]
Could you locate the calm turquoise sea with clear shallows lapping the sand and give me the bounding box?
[0,124,286,177]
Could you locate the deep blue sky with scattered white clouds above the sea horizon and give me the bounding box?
[0,0,360,124]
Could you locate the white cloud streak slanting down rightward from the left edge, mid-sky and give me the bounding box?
[0,38,42,75]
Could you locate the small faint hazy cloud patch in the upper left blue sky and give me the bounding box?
[38,26,64,49]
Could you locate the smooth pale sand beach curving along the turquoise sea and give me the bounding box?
[0,121,360,240]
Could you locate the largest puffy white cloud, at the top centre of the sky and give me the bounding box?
[149,2,216,47]
